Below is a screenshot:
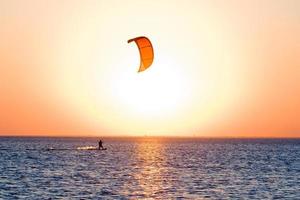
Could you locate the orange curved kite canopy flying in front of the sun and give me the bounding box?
[128,36,154,72]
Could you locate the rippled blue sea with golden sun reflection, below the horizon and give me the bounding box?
[0,137,300,199]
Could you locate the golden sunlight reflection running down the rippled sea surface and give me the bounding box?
[122,137,202,199]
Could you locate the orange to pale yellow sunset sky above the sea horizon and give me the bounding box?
[0,0,300,137]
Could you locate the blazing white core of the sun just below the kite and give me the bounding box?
[113,62,190,117]
